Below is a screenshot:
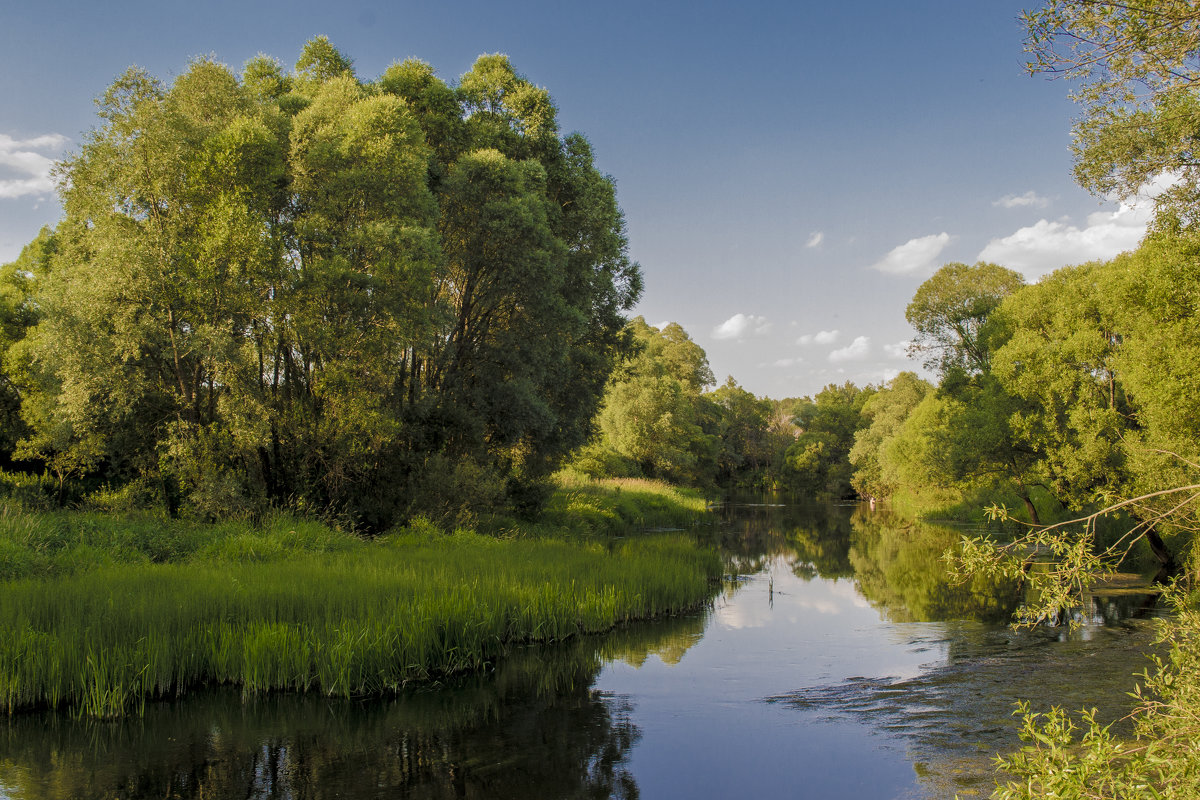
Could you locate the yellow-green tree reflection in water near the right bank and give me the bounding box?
[850,509,1018,622]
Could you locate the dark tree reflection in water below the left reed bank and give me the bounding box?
[0,615,703,800]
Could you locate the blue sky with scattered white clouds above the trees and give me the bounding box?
[0,0,1148,397]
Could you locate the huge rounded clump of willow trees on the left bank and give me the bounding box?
[16,37,641,528]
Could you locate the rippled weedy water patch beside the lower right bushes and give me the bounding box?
[766,618,1154,798]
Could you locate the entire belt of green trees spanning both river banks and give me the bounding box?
[7,29,1200,551]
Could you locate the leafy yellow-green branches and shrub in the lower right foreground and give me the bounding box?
[948,472,1200,800]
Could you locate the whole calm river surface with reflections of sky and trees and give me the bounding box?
[0,506,1153,800]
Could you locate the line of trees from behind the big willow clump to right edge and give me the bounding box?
[575,225,1200,568]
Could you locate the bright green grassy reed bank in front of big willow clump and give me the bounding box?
[0,486,721,716]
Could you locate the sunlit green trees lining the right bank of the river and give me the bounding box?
[787,235,1200,566]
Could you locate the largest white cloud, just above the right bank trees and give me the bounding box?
[978,174,1178,281]
